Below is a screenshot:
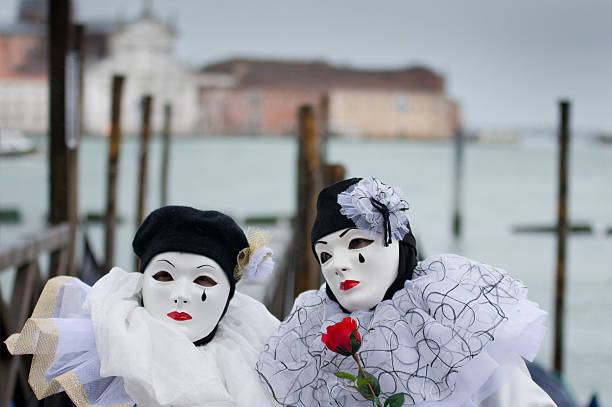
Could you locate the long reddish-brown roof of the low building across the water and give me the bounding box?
[202,58,444,91]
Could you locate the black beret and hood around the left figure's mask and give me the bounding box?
[132,206,249,345]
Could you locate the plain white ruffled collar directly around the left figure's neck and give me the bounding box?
[87,268,278,406]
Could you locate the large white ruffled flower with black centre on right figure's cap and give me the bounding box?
[338,177,410,246]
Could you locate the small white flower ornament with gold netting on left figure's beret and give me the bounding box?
[234,228,274,281]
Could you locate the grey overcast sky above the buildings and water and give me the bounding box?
[0,0,612,132]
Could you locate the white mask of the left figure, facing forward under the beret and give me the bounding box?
[142,252,230,342]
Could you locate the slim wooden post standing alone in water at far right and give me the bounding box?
[553,100,570,376]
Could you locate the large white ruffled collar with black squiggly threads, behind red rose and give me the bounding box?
[257,255,546,407]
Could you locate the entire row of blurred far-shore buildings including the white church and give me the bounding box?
[0,0,460,139]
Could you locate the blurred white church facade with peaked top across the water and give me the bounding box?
[84,13,199,134]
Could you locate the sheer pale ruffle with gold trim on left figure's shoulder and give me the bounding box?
[6,276,133,406]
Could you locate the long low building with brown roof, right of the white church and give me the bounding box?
[199,59,460,138]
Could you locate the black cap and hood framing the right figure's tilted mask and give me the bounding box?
[310,178,417,313]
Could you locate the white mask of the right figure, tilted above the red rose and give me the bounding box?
[314,228,399,312]
